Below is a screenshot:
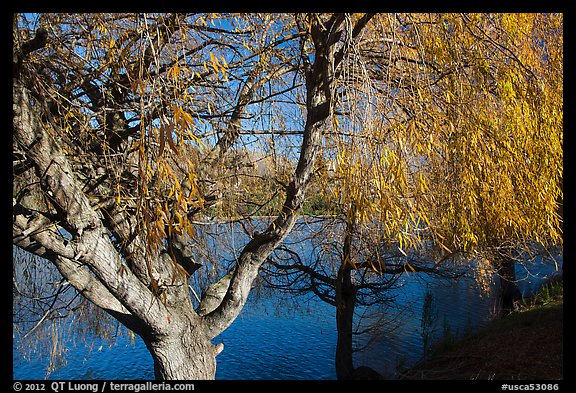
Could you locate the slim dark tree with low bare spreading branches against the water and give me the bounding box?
[261,217,461,380]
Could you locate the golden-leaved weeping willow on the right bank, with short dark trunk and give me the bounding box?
[336,14,563,312]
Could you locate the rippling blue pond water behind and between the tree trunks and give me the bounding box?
[13,220,562,380]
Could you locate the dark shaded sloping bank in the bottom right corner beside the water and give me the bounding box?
[401,281,563,380]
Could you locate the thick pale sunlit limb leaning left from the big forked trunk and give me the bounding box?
[13,81,167,331]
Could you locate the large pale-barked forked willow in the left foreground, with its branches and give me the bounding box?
[13,14,371,379]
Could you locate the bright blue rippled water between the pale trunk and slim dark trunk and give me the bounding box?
[215,300,336,380]
